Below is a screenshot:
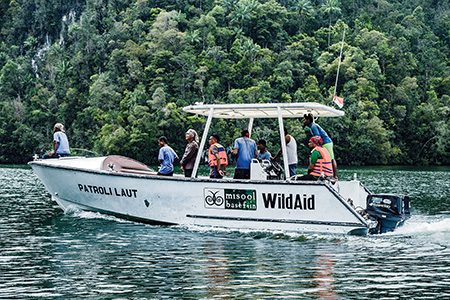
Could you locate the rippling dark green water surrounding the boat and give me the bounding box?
[0,167,450,299]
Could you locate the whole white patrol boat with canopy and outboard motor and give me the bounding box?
[29,103,409,235]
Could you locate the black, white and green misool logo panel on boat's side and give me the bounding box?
[203,188,256,210]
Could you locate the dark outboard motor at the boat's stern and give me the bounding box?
[366,194,410,234]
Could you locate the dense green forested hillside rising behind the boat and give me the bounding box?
[0,0,450,165]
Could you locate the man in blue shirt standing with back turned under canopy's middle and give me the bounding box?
[232,129,258,179]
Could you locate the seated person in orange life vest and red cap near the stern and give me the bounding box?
[298,136,333,180]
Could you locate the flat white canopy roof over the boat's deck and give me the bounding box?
[183,102,344,119]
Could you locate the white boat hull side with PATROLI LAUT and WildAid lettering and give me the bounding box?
[31,161,368,234]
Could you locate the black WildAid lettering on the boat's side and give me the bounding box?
[262,193,316,210]
